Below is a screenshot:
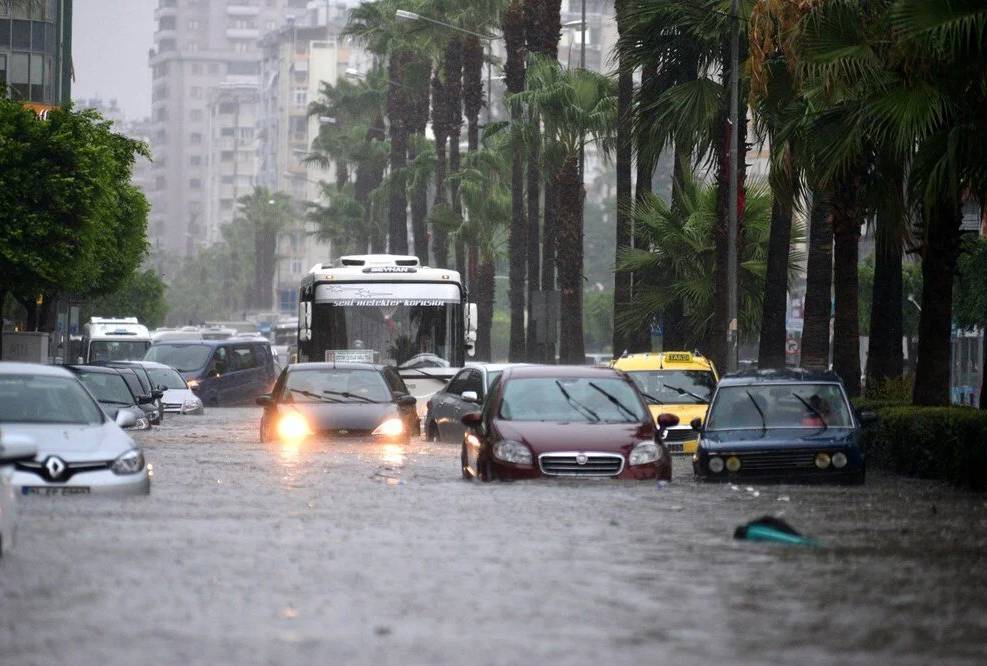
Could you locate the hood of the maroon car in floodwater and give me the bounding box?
[494,420,655,455]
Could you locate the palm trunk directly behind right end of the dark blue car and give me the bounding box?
[833,182,863,398]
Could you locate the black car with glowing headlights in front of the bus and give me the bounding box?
[257,363,420,443]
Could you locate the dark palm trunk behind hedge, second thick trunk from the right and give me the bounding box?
[867,180,905,393]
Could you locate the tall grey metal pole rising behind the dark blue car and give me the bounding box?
[727,0,740,371]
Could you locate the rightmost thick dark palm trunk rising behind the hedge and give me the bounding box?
[912,197,963,406]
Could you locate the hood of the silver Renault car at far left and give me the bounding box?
[3,422,134,462]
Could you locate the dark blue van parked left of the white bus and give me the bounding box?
[144,338,277,406]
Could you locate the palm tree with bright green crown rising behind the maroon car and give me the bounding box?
[508,58,617,363]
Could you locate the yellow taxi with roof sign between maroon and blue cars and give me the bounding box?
[610,352,719,453]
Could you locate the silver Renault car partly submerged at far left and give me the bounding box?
[0,363,151,495]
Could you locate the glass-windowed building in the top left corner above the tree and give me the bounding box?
[0,0,73,111]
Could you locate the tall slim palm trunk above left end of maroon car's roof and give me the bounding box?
[502,0,528,362]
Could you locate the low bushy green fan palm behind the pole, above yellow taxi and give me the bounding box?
[616,170,802,348]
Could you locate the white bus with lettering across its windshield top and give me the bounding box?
[298,255,476,398]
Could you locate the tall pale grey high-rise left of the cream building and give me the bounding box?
[149,0,307,254]
